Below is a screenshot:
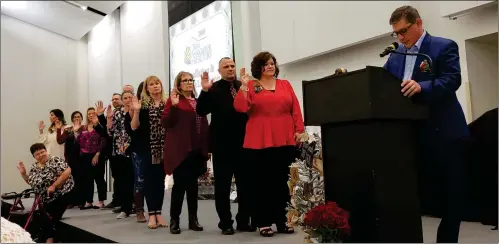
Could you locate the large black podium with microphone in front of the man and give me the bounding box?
[302,66,429,243]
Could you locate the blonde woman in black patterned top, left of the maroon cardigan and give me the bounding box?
[130,76,167,229]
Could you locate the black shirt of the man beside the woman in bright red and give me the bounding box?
[196,79,248,152]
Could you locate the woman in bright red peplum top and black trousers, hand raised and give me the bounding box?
[234,52,304,236]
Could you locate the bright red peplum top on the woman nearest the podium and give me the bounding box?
[234,79,305,149]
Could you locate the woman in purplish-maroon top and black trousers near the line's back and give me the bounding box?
[76,108,107,210]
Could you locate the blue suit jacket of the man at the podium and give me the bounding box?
[384,33,469,142]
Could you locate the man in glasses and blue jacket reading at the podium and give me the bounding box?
[384,6,469,242]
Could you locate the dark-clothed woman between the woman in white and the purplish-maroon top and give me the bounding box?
[57,111,85,208]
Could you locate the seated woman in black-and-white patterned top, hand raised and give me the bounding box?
[17,143,74,243]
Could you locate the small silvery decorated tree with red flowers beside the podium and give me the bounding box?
[287,133,350,243]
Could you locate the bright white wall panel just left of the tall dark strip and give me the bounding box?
[120,1,169,89]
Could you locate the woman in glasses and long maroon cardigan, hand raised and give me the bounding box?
[161,72,209,234]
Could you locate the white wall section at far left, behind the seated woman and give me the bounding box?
[1,14,86,192]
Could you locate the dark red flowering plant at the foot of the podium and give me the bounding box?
[303,202,350,243]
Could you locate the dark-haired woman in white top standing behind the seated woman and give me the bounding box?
[38,109,66,158]
